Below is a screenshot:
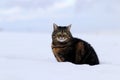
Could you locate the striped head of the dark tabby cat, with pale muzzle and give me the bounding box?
[52,23,72,43]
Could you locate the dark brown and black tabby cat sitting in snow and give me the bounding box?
[51,23,99,65]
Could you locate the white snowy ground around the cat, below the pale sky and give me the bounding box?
[0,32,120,80]
